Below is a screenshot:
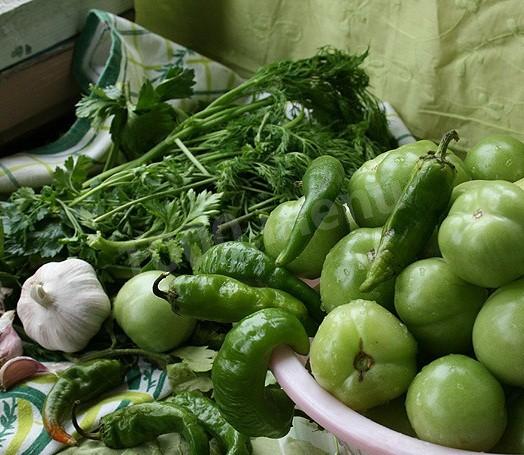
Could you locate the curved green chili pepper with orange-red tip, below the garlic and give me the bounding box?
[42,359,128,445]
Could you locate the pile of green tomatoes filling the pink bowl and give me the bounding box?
[264,135,524,453]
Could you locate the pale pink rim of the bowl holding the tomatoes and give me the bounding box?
[270,346,502,455]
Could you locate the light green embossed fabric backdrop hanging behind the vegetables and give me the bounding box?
[135,0,524,149]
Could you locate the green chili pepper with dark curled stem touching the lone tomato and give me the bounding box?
[153,274,314,328]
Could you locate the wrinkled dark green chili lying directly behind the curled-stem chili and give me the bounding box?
[193,242,324,322]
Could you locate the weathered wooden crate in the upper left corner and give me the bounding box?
[0,0,133,150]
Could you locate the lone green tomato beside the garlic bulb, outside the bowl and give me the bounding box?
[113,270,196,352]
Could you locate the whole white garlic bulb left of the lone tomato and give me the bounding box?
[17,259,111,352]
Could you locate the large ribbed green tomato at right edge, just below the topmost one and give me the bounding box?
[438,180,524,288]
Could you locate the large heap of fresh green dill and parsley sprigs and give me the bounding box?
[0,48,394,285]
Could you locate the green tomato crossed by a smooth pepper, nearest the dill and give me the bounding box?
[263,197,349,278]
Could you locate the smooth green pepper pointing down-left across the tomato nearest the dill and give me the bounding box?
[275,155,344,266]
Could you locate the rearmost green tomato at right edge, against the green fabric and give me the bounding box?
[464,134,524,182]
